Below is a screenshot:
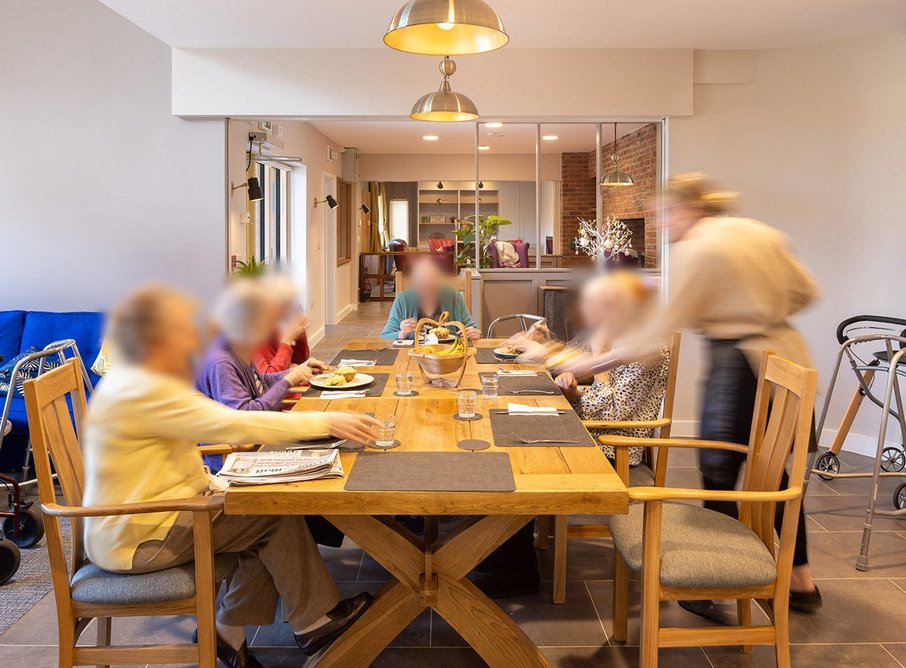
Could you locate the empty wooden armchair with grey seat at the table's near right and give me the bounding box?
[601,355,817,668]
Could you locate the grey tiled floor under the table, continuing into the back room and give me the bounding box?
[0,303,906,668]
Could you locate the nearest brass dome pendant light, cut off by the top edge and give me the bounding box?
[384,0,510,56]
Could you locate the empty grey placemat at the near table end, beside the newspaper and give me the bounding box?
[344,452,516,492]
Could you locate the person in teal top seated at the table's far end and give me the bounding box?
[381,258,481,341]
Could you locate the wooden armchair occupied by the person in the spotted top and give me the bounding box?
[539,332,682,603]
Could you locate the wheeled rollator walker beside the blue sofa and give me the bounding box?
[0,339,93,585]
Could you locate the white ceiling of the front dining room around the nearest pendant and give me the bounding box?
[101,0,906,49]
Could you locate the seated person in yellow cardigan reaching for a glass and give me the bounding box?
[82,286,376,667]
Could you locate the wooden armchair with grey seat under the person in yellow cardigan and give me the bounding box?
[25,360,235,668]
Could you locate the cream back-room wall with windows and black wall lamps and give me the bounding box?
[228,119,358,342]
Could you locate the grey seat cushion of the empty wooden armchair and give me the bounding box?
[610,502,777,588]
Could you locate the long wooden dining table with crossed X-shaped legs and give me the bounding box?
[225,339,628,668]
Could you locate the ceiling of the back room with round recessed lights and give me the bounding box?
[300,119,642,155]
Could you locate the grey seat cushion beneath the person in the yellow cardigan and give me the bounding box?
[70,554,237,605]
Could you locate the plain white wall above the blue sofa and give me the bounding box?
[0,0,226,310]
